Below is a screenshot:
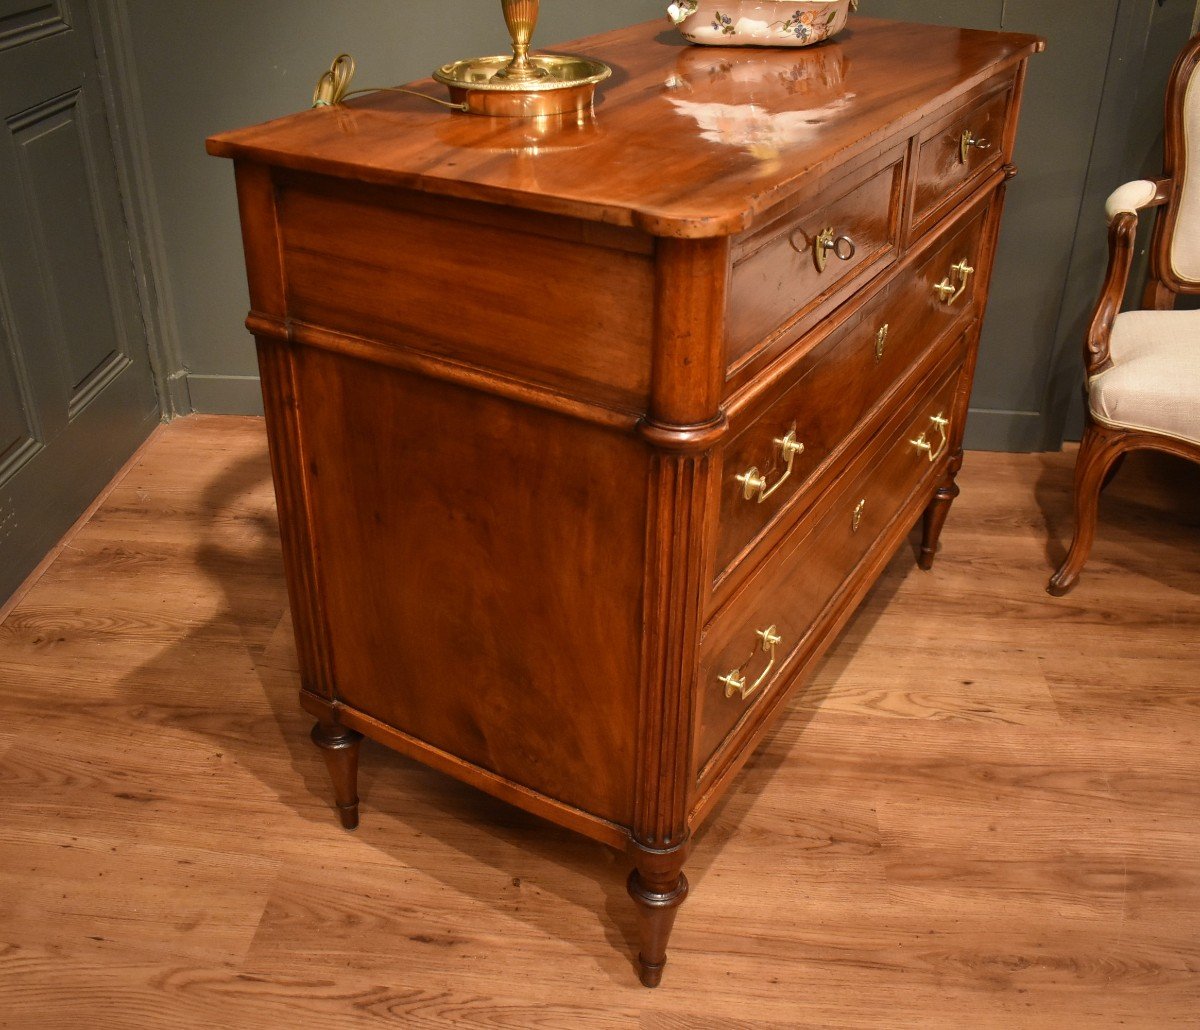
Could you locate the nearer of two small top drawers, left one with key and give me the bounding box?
[726,150,904,370]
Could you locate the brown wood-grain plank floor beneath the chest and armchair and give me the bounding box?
[0,418,1200,1030]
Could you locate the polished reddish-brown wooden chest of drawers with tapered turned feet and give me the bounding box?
[209,19,1040,986]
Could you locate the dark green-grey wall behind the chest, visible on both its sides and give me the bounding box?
[116,0,1195,450]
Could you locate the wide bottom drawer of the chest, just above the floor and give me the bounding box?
[694,367,960,778]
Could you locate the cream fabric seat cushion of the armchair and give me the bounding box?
[1087,311,1200,444]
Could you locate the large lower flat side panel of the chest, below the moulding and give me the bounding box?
[294,349,648,826]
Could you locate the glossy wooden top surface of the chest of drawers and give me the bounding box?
[208,17,1043,236]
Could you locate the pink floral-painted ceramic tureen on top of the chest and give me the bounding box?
[667,0,858,47]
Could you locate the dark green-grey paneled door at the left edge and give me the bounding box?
[0,0,158,604]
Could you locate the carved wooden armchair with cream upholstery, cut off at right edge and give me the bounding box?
[1049,35,1200,595]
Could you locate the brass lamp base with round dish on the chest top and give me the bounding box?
[433,0,612,118]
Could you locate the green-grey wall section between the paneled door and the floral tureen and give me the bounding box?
[119,0,665,413]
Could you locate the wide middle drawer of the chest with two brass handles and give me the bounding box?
[713,206,985,586]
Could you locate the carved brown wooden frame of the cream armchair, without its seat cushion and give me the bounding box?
[1048,35,1200,597]
